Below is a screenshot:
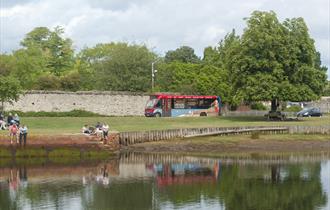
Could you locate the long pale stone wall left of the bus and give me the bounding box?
[5,91,149,116]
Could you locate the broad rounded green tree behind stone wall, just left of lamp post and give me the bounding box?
[78,43,156,91]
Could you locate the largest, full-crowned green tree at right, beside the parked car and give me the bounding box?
[230,11,326,110]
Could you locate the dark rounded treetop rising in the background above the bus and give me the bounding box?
[165,46,200,63]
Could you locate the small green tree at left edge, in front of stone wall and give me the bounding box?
[0,76,21,111]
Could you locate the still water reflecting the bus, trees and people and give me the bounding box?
[0,154,330,210]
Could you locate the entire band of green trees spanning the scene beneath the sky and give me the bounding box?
[0,11,330,103]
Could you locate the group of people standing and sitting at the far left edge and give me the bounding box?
[0,112,28,146]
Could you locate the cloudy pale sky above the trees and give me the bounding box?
[0,0,330,79]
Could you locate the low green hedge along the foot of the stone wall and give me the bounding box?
[5,109,104,117]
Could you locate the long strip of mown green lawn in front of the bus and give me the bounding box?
[0,115,330,135]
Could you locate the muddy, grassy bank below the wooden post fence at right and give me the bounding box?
[124,135,330,154]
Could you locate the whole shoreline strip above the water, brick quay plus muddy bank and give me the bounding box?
[0,133,330,157]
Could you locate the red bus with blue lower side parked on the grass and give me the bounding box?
[144,94,221,117]
